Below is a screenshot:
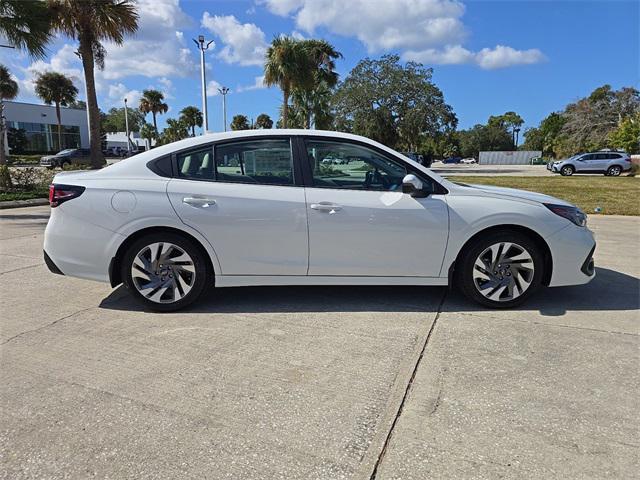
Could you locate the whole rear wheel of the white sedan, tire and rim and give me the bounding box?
[121,233,209,312]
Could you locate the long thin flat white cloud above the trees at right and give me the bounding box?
[403,45,546,70]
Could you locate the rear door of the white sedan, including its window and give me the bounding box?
[167,136,308,275]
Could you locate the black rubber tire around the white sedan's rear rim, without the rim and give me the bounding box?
[120,232,213,312]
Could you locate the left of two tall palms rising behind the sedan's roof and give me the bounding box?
[264,35,311,128]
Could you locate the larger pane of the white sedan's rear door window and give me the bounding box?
[215,139,293,185]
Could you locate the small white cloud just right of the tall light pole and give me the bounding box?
[202,12,267,66]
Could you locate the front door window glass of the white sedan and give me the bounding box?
[305,140,407,191]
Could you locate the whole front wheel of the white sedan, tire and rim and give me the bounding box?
[457,230,544,308]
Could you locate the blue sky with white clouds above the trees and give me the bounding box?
[0,0,640,131]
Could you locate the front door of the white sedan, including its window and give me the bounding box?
[298,137,448,277]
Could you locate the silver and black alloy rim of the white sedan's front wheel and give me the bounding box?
[473,242,534,302]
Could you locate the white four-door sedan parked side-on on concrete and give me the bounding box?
[44,130,595,311]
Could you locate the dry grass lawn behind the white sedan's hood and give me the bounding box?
[447,175,640,215]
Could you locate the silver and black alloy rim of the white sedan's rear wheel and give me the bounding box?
[131,242,196,303]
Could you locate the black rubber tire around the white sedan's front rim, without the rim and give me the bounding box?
[456,230,545,308]
